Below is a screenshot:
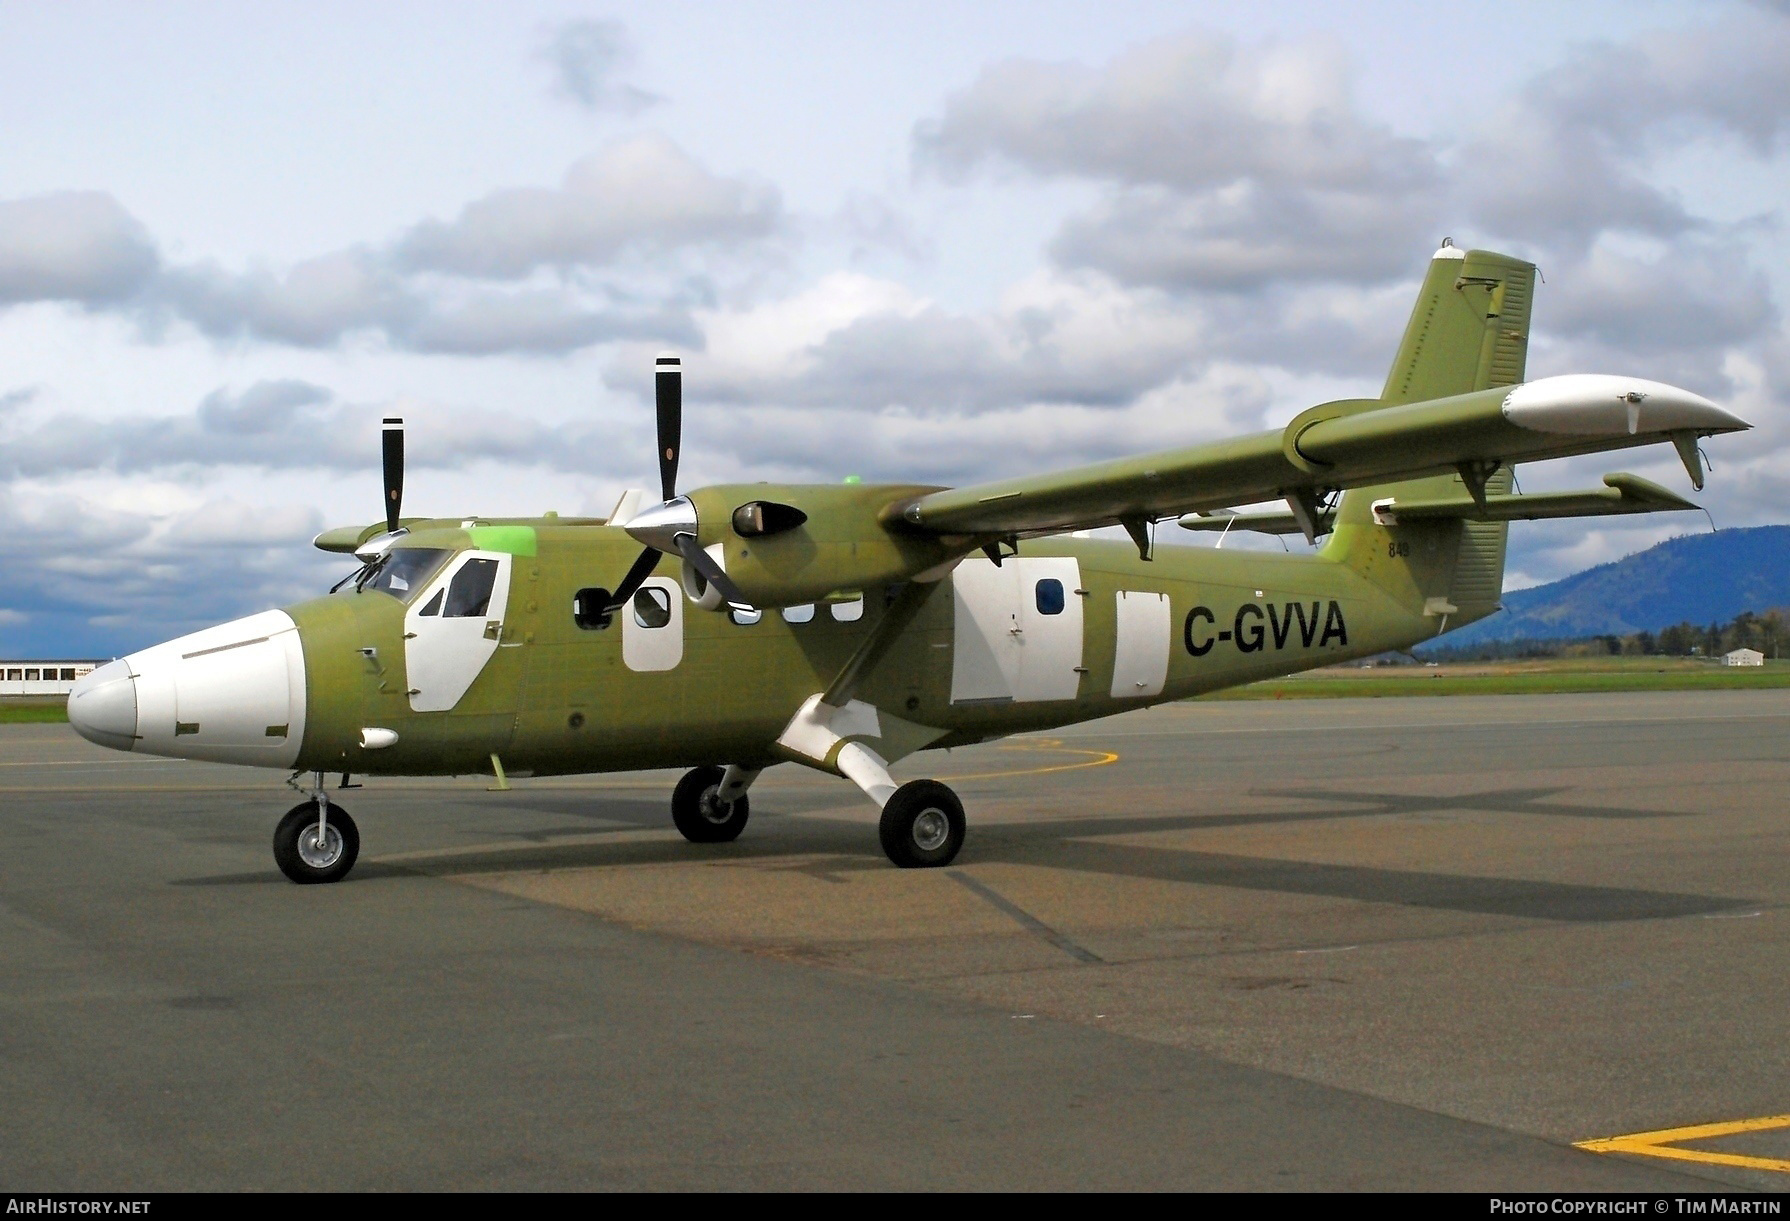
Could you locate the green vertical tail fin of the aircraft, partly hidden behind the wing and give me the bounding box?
[1325,242,1536,632]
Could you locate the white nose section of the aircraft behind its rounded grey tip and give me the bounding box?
[122,611,304,768]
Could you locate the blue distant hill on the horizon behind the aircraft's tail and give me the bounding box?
[1437,526,1790,648]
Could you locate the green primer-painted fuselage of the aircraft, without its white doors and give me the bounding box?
[288,519,1453,775]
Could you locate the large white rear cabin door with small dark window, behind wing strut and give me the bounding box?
[950,557,1081,704]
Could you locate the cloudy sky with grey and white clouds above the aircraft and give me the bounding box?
[0,0,1790,655]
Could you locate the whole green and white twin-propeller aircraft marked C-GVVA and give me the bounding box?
[68,242,1749,883]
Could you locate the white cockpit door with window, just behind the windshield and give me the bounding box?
[405,551,510,713]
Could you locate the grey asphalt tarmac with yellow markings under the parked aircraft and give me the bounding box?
[0,691,1790,1194]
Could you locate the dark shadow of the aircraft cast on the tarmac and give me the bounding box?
[174,788,1756,922]
